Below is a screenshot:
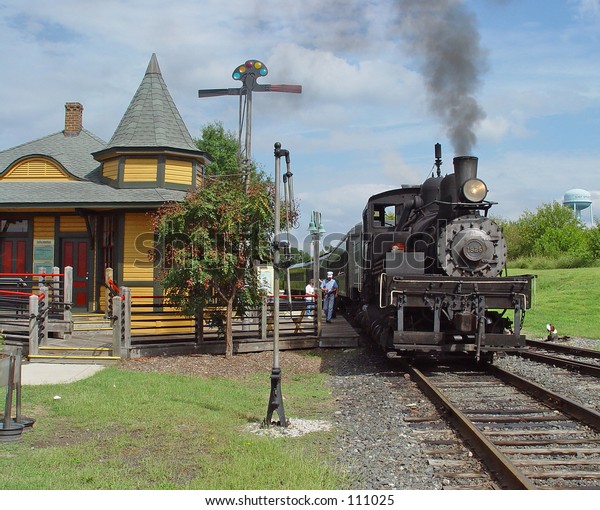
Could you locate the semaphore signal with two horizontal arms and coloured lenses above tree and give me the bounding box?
[198,60,302,191]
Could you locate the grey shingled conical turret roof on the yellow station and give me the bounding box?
[107,53,199,152]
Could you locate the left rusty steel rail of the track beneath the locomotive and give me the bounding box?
[403,363,537,490]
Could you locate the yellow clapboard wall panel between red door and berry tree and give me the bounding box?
[123,213,154,280]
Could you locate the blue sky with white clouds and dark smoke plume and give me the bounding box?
[0,0,600,248]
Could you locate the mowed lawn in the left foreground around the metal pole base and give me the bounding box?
[0,367,345,490]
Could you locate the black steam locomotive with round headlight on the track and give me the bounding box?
[296,144,534,361]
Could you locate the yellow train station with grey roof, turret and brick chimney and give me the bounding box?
[0,55,209,311]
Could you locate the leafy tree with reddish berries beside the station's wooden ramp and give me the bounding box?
[154,124,274,357]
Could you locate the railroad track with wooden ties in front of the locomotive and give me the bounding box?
[405,366,600,489]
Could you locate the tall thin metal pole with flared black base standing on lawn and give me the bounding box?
[263,142,288,427]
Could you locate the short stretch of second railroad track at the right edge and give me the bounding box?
[519,340,600,377]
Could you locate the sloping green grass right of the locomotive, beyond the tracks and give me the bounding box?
[509,267,600,339]
